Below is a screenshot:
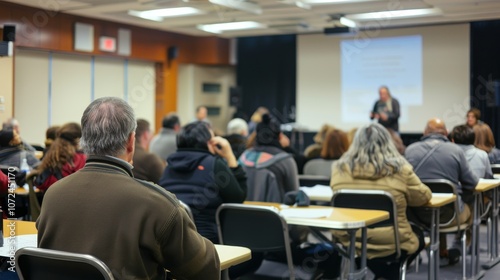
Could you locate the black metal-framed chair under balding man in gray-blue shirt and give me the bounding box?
[422,179,473,279]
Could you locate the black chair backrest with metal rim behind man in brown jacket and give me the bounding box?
[15,247,114,280]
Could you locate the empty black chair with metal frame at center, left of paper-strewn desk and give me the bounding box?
[216,203,295,280]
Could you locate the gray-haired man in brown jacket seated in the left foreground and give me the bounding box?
[36,97,220,280]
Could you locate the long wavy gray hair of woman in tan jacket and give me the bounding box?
[335,123,407,176]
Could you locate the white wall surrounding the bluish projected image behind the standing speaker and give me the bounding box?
[297,24,470,132]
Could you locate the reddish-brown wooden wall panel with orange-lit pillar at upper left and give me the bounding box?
[0,2,229,132]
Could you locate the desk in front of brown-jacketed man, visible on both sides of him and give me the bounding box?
[0,220,252,270]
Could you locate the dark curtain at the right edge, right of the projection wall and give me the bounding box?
[470,20,500,142]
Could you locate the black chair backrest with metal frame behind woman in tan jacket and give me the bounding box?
[332,189,401,258]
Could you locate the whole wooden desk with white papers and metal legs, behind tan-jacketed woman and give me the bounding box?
[244,201,389,279]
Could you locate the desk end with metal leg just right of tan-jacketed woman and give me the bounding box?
[422,193,457,280]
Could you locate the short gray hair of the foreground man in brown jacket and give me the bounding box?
[80,97,137,157]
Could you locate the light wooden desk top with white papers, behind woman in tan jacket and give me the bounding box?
[244,201,389,229]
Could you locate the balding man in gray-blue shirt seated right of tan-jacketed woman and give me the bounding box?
[405,118,479,265]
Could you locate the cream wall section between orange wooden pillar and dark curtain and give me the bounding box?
[177,64,236,134]
